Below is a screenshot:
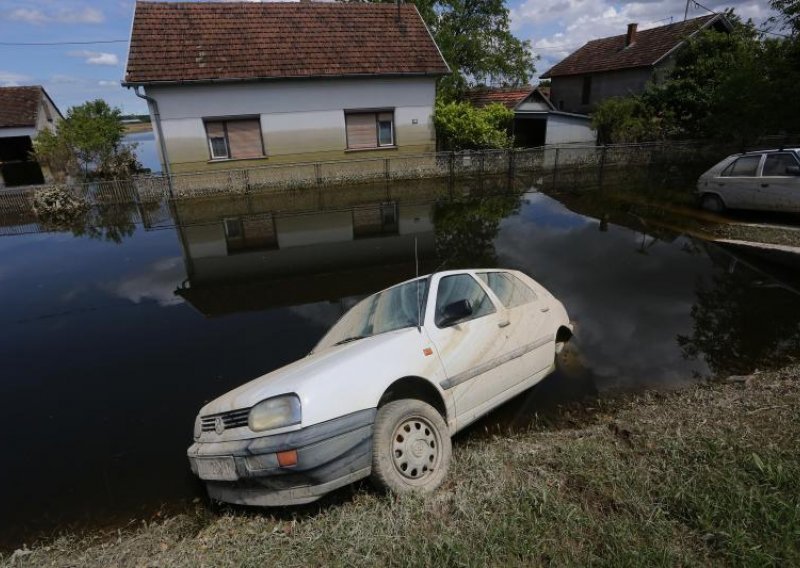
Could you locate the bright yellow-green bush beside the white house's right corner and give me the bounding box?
[433,100,514,150]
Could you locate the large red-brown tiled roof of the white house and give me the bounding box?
[125,2,449,83]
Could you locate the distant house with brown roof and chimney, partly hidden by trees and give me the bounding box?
[542,14,731,113]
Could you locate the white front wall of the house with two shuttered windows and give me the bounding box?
[146,78,436,169]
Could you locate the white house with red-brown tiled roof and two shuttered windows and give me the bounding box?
[124,2,450,173]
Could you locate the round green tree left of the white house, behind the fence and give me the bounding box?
[33,99,141,179]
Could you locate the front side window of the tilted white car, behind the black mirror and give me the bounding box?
[434,274,495,327]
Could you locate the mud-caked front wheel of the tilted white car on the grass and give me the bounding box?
[370,399,452,494]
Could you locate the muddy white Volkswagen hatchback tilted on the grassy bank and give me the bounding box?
[188,269,572,506]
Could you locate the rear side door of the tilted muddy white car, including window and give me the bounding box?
[477,271,555,382]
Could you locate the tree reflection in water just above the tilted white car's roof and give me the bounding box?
[433,193,521,269]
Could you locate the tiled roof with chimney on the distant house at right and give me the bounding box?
[542,15,723,78]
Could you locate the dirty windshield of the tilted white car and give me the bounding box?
[314,278,428,351]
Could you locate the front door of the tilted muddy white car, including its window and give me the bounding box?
[425,272,519,428]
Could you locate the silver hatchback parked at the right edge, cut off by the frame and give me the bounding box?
[697,148,800,212]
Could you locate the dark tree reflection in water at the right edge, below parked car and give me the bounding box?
[678,250,800,374]
